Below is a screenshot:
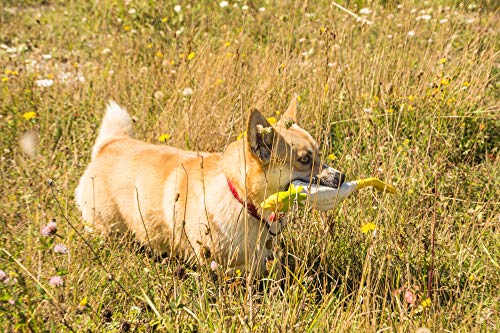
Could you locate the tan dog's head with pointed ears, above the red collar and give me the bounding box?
[246,97,345,201]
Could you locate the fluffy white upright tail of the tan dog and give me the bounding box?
[92,100,132,159]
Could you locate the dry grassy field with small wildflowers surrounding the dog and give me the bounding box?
[0,0,500,332]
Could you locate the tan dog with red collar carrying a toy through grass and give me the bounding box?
[76,98,344,276]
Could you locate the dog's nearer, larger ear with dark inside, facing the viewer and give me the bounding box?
[247,109,276,165]
